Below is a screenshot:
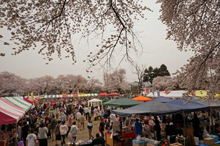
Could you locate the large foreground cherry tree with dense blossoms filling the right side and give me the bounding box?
[158,0,220,99]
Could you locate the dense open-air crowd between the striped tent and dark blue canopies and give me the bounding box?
[1,98,113,146]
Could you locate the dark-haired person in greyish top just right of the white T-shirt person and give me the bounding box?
[38,123,48,146]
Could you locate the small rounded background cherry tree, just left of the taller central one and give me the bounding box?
[82,78,102,93]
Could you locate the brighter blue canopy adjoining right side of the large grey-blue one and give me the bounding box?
[166,99,210,112]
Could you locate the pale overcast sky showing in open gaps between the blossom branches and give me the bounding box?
[0,0,193,82]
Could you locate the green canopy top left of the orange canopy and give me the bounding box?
[104,98,142,107]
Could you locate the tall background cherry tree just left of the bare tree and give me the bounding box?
[103,69,130,92]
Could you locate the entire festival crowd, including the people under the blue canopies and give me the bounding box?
[1,96,219,146]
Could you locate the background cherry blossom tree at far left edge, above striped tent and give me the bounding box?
[0,72,26,96]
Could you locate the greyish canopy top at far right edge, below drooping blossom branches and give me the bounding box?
[191,96,220,109]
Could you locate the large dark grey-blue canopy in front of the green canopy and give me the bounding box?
[112,100,183,116]
